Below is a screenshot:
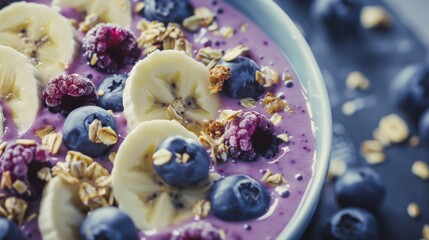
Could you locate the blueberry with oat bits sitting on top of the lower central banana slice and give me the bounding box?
[153,136,210,188]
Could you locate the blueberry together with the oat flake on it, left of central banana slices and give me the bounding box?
[63,106,118,157]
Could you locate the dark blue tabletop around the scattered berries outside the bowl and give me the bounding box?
[275,0,429,240]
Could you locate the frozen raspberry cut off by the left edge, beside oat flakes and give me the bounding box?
[0,143,46,180]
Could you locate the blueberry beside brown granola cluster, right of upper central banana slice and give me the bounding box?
[219,57,264,99]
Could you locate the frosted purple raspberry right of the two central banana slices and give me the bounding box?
[225,112,277,161]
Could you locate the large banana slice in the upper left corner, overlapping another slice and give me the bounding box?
[0,2,78,87]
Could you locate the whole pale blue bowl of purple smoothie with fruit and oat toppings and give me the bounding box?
[0,0,331,240]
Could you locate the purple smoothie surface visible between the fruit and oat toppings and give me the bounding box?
[3,0,316,240]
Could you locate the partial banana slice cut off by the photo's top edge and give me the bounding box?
[52,0,132,27]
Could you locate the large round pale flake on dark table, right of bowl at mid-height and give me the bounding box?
[378,114,409,143]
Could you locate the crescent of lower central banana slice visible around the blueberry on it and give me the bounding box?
[112,120,210,230]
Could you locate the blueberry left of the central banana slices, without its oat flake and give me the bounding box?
[63,106,118,157]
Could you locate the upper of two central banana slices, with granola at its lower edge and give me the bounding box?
[123,50,219,133]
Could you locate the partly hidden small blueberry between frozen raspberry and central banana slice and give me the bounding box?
[98,74,128,112]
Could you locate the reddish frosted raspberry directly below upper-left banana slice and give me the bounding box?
[43,74,97,116]
